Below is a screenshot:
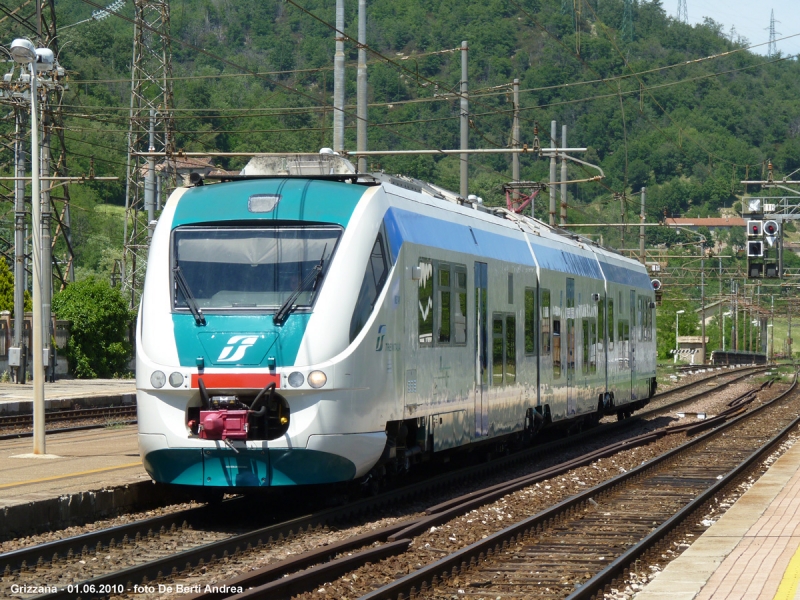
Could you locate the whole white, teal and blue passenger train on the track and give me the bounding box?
[136,153,656,492]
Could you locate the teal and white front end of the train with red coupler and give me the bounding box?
[136,178,402,488]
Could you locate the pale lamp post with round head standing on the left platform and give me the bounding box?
[9,38,44,454]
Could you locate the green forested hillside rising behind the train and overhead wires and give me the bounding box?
[40,0,800,271]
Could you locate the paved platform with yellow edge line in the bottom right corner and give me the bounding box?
[634,442,800,600]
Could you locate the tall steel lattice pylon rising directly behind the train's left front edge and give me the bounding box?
[122,0,175,308]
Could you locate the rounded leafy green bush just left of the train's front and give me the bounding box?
[53,278,133,379]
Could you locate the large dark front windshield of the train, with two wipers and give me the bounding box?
[172,227,342,312]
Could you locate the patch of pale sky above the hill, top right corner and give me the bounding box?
[680,0,800,56]
